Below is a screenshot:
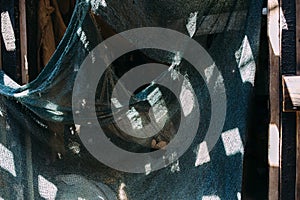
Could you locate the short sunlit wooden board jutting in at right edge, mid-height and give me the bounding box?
[282,76,300,112]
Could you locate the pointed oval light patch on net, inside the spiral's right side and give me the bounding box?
[179,79,194,116]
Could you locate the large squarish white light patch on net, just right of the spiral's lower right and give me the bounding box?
[221,128,244,156]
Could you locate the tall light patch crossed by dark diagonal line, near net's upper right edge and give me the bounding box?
[236,36,256,86]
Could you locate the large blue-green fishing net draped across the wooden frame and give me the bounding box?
[0,0,262,200]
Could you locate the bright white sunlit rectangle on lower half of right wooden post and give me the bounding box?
[268,124,280,167]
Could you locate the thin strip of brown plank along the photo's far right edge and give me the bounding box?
[295,0,300,199]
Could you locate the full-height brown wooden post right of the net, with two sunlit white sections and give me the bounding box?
[268,0,281,200]
